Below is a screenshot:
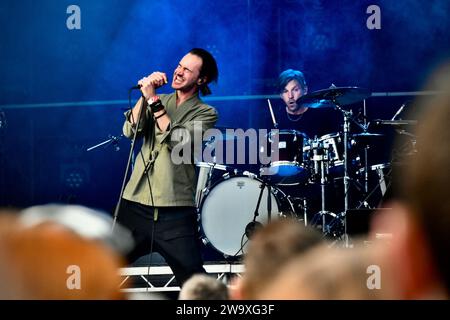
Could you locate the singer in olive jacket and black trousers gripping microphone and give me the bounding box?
[118,48,218,286]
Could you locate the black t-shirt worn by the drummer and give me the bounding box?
[267,106,343,139]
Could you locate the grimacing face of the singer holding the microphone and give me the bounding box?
[172,53,203,92]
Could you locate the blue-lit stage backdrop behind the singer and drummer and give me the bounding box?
[0,0,450,210]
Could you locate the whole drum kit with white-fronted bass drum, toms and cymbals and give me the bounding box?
[196,86,400,258]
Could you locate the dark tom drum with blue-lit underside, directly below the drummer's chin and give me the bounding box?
[260,130,309,185]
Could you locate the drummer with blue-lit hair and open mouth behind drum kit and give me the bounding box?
[272,69,341,138]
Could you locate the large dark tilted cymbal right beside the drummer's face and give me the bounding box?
[297,87,370,109]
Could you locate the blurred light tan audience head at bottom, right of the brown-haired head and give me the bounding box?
[257,245,395,300]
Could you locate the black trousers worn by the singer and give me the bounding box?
[118,199,206,286]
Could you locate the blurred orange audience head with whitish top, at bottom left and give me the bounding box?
[0,205,131,300]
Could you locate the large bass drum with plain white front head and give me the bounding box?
[200,173,294,257]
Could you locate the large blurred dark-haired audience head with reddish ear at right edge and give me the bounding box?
[373,64,450,299]
